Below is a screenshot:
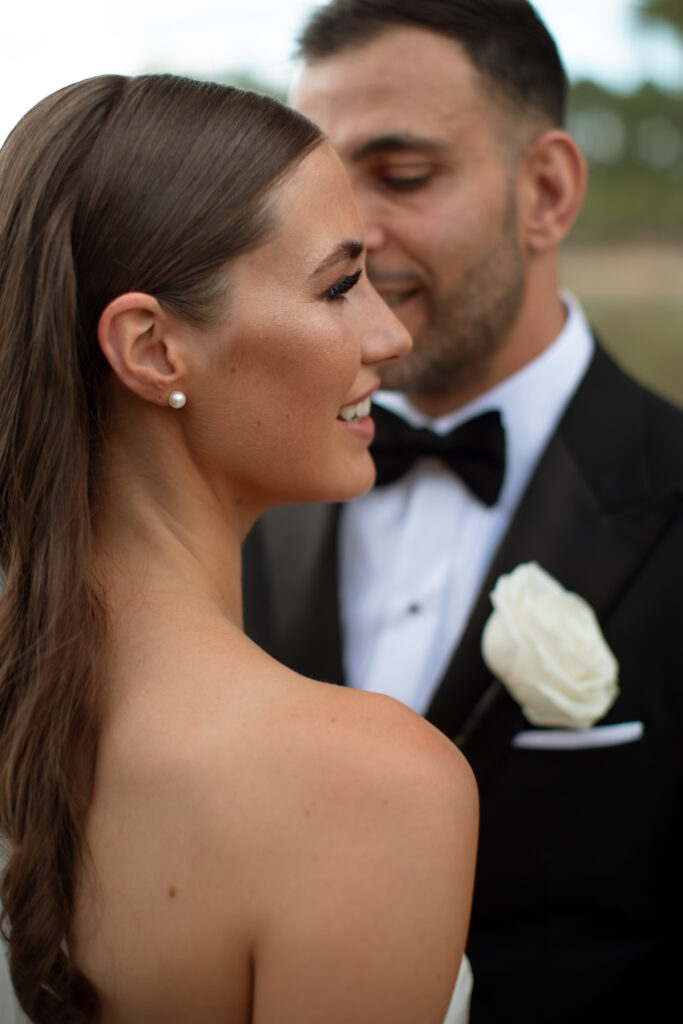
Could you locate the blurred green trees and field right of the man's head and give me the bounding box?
[562,0,683,406]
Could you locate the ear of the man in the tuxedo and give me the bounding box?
[519,129,588,253]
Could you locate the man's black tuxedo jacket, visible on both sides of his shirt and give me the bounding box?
[245,348,683,1024]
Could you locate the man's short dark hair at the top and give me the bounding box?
[297,0,567,125]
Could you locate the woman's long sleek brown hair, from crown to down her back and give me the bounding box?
[0,75,322,1024]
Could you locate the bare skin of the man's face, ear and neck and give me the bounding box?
[292,27,586,415]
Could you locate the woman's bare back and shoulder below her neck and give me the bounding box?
[72,598,475,1024]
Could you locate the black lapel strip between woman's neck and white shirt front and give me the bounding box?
[261,505,343,683]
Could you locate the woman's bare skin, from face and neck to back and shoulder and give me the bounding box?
[69,145,477,1024]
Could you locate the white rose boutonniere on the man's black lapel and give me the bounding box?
[481,562,618,729]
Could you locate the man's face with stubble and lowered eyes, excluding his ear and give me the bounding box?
[292,28,524,411]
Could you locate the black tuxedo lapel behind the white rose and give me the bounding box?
[427,350,670,783]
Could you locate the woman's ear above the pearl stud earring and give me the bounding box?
[97,292,186,403]
